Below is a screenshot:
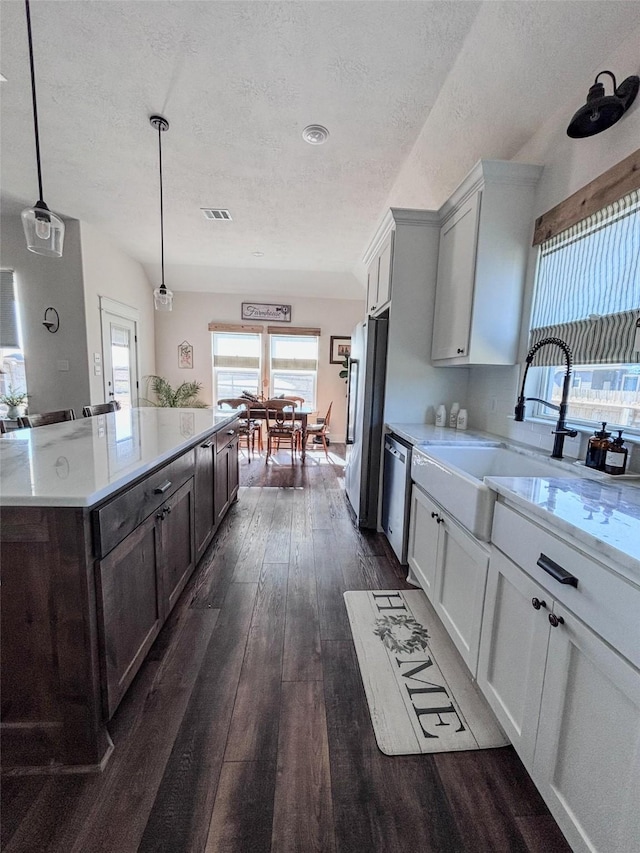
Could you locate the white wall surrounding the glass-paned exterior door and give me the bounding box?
[80,222,155,405]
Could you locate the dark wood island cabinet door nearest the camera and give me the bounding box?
[97,513,164,719]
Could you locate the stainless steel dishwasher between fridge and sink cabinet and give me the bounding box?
[382,435,411,565]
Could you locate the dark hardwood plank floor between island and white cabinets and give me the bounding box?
[0,446,569,853]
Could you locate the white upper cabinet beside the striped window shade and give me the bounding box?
[431,160,542,366]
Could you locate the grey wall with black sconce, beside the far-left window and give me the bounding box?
[0,216,89,415]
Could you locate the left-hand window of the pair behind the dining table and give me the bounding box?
[213,332,262,400]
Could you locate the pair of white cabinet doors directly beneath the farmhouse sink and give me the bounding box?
[408,485,489,676]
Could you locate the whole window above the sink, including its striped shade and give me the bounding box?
[530,191,640,430]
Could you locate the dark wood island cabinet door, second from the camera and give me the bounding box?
[159,479,196,616]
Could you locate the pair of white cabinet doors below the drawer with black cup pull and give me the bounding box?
[478,549,640,853]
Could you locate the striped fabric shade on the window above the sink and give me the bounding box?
[529,190,640,365]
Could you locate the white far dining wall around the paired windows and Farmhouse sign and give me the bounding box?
[152,292,365,442]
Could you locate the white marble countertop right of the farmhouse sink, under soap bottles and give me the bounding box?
[485,477,640,583]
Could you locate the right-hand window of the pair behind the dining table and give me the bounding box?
[269,334,318,406]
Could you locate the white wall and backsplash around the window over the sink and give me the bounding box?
[469,30,640,461]
